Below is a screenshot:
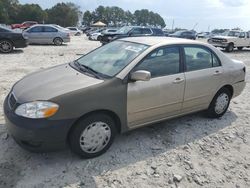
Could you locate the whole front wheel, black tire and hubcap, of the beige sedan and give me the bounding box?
[69,113,117,158]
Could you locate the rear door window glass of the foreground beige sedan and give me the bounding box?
[184,47,221,71]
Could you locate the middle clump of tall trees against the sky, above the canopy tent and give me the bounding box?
[83,6,166,27]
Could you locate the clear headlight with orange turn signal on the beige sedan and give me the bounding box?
[15,101,59,119]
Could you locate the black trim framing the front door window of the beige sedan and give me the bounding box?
[130,44,184,79]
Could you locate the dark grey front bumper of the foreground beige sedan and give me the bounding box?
[4,96,75,152]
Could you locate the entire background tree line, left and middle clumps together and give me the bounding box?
[0,0,165,27]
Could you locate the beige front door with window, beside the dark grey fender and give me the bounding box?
[127,46,185,128]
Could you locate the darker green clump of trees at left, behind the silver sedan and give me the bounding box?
[0,0,80,27]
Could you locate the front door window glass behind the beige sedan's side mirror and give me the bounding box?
[134,47,180,78]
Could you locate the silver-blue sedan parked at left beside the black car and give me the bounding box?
[23,24,70,46]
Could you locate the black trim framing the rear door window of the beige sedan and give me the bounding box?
[181,44,222,72]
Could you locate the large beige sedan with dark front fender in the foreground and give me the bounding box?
[4,37,246,158]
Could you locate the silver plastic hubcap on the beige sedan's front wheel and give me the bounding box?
[79,121,111,153]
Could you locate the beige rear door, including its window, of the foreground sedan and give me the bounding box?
[183,45,223,112]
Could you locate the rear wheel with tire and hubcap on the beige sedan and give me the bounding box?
[207,88,232,118]
